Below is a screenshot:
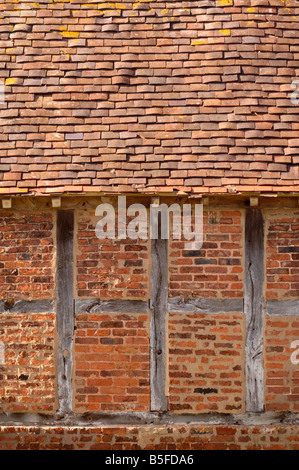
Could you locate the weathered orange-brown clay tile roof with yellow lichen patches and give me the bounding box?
[0,0,299,194]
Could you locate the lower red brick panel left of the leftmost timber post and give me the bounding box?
[0,313,57,413]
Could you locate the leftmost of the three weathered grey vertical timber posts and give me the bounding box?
[56,210,74,414]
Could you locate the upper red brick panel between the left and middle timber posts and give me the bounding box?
[77,212,149,299]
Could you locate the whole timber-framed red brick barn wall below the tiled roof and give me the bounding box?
[0,197,299,449]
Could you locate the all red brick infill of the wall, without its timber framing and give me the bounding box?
[0,203,299,448]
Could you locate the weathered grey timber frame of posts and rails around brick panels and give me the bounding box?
[0,195,299,425]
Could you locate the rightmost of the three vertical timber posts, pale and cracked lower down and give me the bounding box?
[244,209,264,412]
